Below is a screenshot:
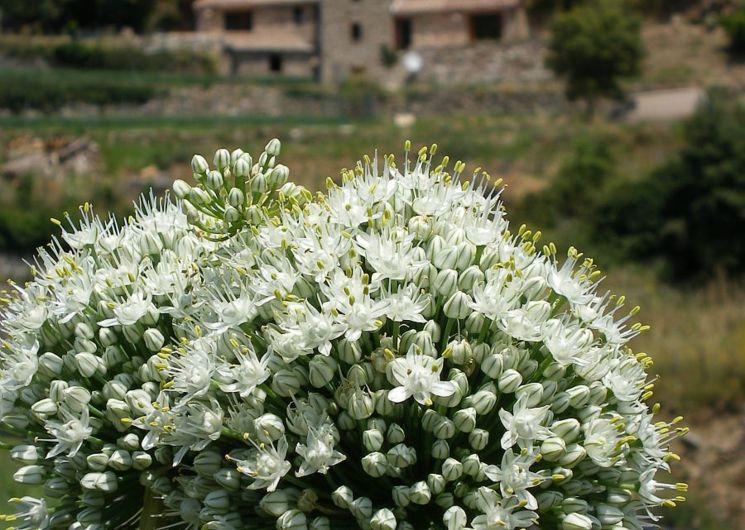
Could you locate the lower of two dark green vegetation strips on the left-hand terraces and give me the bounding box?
[0,71,163,112]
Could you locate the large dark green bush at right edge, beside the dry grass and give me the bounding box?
[594,92,745,278]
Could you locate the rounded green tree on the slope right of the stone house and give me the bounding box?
[546,0,644,113]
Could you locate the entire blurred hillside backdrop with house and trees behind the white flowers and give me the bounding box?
[0,0,745,530]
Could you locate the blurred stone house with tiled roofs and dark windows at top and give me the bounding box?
[194,0,529,83]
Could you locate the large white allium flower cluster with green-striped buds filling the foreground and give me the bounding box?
[0,140,685,530]
